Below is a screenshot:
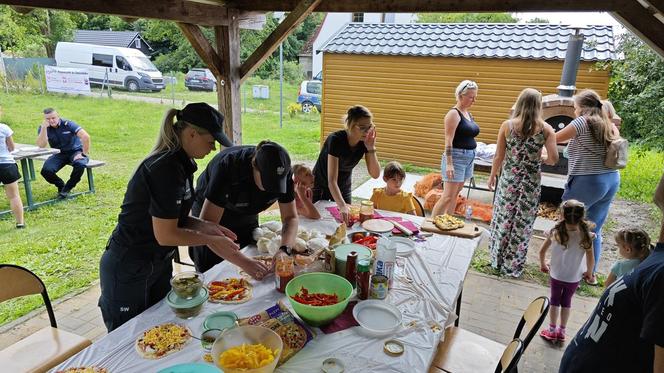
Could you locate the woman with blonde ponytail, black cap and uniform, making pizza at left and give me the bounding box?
[99,103,268,332]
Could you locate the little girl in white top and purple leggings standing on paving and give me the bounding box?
[540,199,595,342]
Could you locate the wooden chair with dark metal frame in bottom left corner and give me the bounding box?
[0,264,92,372]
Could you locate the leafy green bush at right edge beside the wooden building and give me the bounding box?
[609,33,664,150]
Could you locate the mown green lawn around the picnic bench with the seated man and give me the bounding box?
[0,93,320,324]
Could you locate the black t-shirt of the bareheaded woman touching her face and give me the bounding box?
[314,130,367,195]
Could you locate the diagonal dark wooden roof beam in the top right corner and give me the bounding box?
[611,1,664,58]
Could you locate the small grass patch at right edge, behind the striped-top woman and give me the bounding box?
[618,146,664,202]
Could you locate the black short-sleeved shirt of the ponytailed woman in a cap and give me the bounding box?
[112,149,196,248]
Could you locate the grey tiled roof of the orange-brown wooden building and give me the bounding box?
[321,23,616,61]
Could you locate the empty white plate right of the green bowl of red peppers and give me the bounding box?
[353,299,401,337]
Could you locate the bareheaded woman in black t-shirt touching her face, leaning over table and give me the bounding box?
[312,105,380,223]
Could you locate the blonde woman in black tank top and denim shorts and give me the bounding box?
[431,80,480,216]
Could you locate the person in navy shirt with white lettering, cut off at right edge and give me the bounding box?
[560,175,664,373]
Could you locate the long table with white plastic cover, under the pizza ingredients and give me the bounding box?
[49,202,480,373]
